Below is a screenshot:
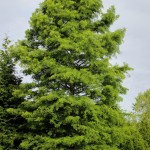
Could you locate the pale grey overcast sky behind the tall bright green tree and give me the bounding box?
[0,0,150,111]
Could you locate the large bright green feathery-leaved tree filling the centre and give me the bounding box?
[11,0,129,150]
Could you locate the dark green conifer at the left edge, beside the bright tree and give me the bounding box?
[0,37,22,150]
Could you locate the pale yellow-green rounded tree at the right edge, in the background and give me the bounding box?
[134,90,150,147]
